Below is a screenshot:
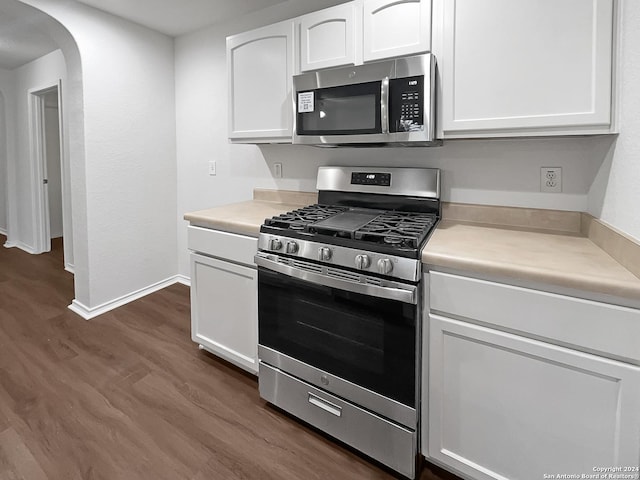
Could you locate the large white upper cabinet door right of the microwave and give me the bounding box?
[433,0,614,138]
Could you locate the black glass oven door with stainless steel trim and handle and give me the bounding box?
[256,256,419,426]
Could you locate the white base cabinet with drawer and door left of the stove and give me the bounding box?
[189,227,258,375]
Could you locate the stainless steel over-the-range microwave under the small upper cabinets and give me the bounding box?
[293,54,442,146]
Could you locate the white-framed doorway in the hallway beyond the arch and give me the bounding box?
[29,83,72,271]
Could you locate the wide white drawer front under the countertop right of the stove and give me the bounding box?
[429,272,640,364]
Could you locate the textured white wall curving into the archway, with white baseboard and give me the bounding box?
[22,0,177,316]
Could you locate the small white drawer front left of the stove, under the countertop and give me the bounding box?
[187,226,258,266]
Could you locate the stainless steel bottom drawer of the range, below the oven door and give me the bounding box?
[259,362,417,478]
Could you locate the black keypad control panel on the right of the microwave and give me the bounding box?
[389,75,424,133]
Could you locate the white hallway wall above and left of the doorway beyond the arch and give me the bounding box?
[8,50,66,251]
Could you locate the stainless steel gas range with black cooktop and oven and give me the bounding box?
[255,167,440,478]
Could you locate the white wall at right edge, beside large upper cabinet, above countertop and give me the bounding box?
[589,0,640,240]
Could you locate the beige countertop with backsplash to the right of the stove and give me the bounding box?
[422,206,640,301]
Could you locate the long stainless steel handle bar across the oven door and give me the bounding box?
[254,255,418,305]
